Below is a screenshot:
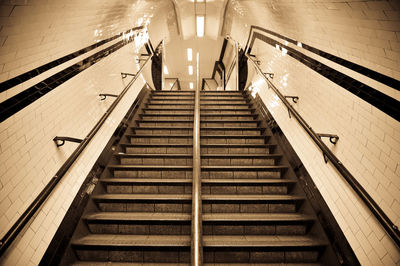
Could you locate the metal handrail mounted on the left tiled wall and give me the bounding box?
[0,39,161,256]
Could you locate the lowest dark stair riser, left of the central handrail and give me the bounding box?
[76,247,190,263]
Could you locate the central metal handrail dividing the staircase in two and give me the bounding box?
[190,51,203,266]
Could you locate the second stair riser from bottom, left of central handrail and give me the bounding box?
[88,221,190,235]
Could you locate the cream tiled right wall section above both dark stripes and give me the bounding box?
[227,0,400,80]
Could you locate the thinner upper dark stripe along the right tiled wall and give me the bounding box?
[250,25,400,90]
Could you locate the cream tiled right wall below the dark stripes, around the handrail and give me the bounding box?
[245,37,400,265]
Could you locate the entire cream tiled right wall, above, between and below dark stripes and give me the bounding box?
[227,0,400,265]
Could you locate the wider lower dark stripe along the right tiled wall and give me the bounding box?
[249,32,400,121]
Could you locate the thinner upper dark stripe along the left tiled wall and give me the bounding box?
[0,26,143,93]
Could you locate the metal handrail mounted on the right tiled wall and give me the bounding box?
[246,53,400,247]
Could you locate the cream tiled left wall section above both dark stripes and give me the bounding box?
[0,0,171,82]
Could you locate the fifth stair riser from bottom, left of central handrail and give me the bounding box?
[114,170,193,179]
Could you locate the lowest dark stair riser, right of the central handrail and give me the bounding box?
[203,248,319,264]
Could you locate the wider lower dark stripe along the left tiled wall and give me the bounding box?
[0,40,130,123]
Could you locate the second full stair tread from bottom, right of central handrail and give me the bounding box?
[202,213,315,222]
